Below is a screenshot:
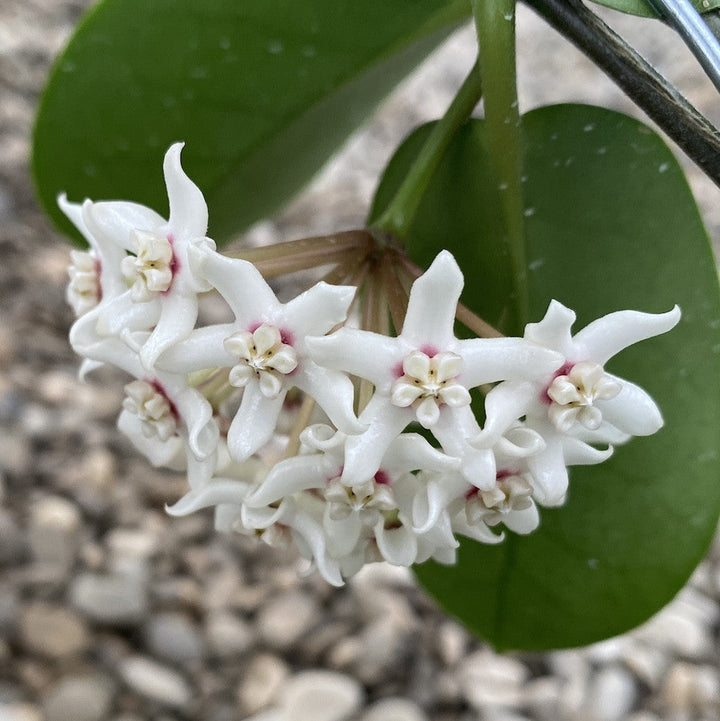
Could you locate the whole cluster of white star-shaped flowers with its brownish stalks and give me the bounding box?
[59,144,680,585]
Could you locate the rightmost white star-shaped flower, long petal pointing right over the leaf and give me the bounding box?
[477,301,680,505]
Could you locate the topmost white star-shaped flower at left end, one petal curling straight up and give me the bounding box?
[58,143,215,371]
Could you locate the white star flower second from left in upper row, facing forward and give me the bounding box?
[158,251,364,460]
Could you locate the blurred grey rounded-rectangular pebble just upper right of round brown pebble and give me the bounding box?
[70,573,148,626]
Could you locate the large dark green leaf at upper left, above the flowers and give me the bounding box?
[33,0,469,246]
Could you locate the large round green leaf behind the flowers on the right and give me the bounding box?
[379,105,720,649]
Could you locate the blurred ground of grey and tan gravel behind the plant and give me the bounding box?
[0,0,720,721]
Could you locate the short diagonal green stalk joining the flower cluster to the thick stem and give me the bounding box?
[372,62,482,242]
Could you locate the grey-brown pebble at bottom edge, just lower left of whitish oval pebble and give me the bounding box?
[43,674,115,721]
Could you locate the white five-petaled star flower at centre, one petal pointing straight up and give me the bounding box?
[308,251,562,489]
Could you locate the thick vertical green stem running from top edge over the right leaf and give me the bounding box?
[471,0,530,330]
